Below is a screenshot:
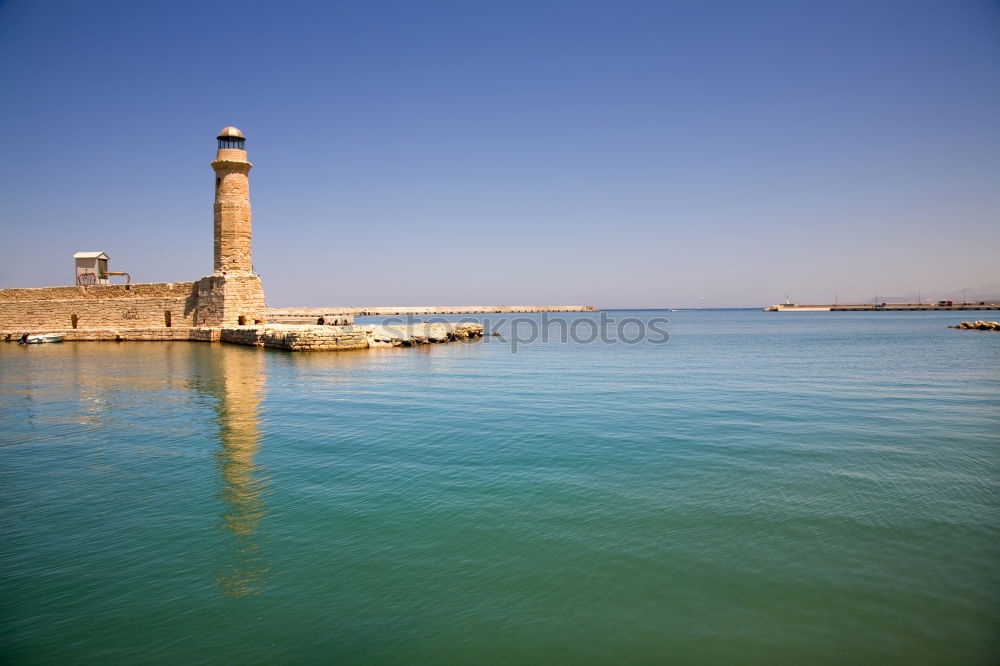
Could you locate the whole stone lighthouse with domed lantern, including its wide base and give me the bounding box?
[197,127,265,327]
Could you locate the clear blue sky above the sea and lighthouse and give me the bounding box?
[0,0,1000,307]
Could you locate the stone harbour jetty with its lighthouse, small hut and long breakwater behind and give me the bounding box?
[0,127,597,351]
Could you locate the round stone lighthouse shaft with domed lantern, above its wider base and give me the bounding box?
[212,127,253,275]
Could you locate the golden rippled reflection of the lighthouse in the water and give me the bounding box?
[210,345,269,597]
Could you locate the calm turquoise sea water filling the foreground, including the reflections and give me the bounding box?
[0,311,1000,664]
